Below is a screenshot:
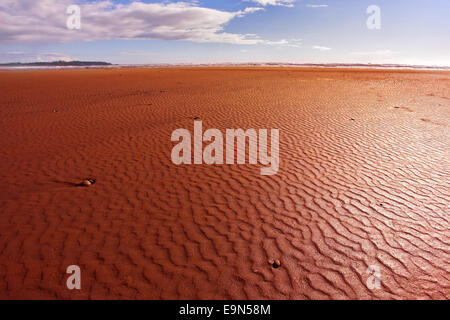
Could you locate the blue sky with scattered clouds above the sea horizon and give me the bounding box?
[0,0,450,66]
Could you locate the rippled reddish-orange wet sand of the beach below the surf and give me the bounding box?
[0,68,450,299]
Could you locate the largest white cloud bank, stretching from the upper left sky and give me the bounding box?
[0,0,286,45]
